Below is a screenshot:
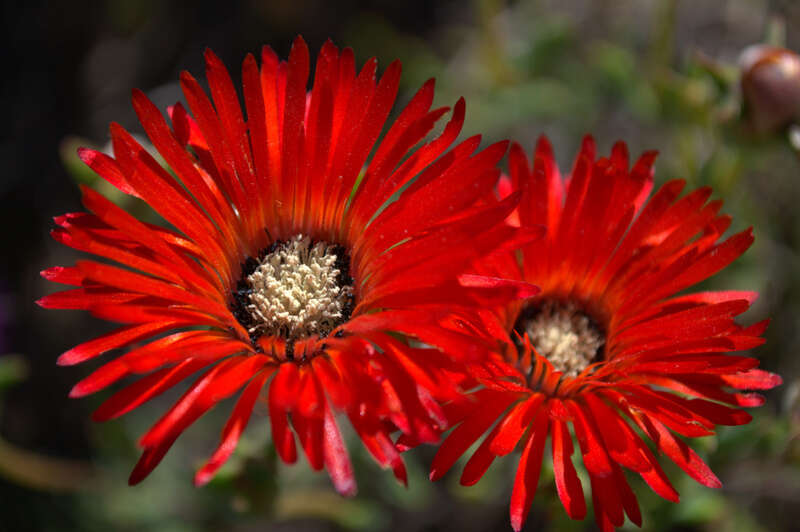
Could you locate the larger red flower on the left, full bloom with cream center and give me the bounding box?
[39,38,526,494]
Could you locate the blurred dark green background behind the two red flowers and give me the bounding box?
[0,0,800,532]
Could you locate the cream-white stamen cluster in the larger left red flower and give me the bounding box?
[245,235,353,339]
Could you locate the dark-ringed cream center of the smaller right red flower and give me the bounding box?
[514,300,605,377]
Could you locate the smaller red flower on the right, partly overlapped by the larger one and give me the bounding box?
[428,137,781,530]
